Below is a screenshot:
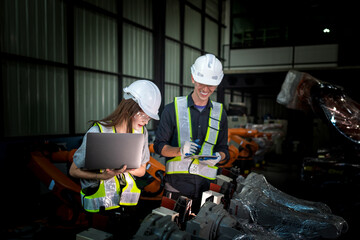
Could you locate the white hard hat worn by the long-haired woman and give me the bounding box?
[123,80,161,120]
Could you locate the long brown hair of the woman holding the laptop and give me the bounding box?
[90,99,141,133]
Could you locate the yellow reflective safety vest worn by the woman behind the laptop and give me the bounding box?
[80,123,144,212]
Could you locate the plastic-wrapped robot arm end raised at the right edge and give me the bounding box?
[277,70,360,144]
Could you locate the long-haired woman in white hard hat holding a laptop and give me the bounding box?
[69,80,161,212]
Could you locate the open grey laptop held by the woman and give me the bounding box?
[84,133,144,170]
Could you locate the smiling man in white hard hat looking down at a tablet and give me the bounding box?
[154,54,229,213]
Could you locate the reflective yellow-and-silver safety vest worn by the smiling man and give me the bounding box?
[166,96,223,180]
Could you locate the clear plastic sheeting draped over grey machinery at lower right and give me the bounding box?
[229,172,348,239]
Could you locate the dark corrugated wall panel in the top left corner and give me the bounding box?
[0,0,67,63]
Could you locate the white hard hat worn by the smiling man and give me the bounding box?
[191,54,224,86]
